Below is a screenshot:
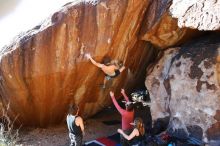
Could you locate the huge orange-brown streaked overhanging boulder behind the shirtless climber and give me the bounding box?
[0,0,154,126]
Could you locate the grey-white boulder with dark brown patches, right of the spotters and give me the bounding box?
[145,35,220,140]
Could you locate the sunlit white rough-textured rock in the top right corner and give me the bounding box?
[170,0,220,30]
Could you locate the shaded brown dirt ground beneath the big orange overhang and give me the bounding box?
[18,107,121,146]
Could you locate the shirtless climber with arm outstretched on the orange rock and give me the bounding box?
[86,54,125,88]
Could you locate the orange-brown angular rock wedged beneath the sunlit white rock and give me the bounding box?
[140,0,200,49]
